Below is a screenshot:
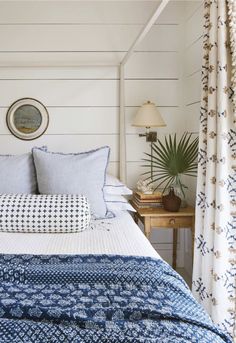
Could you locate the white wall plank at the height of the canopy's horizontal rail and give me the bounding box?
[0,51,179,69]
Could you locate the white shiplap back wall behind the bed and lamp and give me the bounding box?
[0,1,199,266]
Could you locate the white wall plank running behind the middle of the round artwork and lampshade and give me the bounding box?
[0,107,183,136]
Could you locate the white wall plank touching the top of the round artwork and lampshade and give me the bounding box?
[0,80,178,107]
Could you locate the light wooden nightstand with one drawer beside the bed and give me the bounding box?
[131,200,195,269]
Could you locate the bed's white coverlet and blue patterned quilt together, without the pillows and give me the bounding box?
[0,211,230,343]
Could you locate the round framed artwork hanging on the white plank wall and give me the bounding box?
[7,98,49,140]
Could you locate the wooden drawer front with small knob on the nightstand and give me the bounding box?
[151,216,193,228]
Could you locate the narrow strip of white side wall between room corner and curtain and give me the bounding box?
[183,1,204,274]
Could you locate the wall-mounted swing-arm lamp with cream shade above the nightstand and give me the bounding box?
[132,101,166,180]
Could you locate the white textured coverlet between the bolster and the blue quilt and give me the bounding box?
[0,211,161,258]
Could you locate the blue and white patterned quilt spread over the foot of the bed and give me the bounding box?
[0,255,231,343]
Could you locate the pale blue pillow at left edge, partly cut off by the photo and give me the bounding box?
[0,153,37,194]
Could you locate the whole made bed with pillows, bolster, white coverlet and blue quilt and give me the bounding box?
[0,147,230,343]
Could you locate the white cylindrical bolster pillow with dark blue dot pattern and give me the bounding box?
[0,194,91,233]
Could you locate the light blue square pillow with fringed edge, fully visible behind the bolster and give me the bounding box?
[33,146,110,218]
